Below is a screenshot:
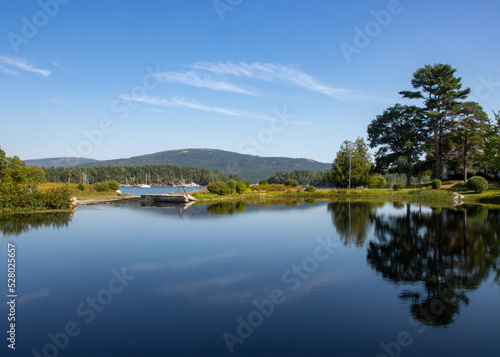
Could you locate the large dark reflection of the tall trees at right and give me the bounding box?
[367,205,500,326]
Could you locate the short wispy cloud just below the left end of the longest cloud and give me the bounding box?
[155,71,253,95]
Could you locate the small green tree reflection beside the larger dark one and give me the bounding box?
[328,201,385,247]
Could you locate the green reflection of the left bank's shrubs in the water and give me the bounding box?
[0,212,72,237]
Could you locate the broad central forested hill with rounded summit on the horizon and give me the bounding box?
[79,149,331,182]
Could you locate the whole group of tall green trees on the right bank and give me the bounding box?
[329,64,500,187]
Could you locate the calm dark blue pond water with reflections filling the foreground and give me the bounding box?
[0,200,500,357]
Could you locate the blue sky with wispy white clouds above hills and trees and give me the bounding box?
[0,0,500,162]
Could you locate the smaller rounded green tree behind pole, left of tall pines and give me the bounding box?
[329,137,371,187]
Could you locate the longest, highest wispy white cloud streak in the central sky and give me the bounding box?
[190,62,351,99]
